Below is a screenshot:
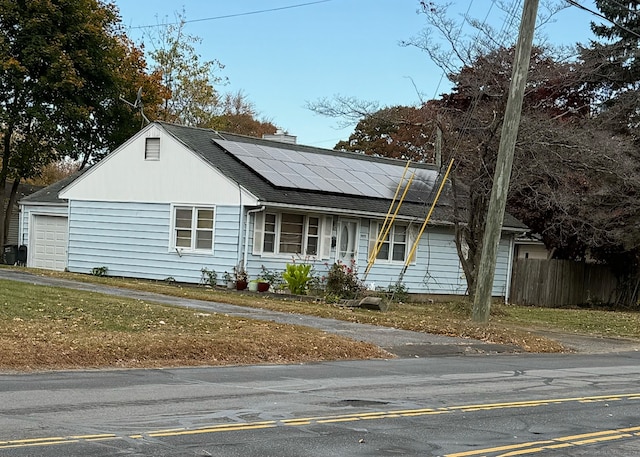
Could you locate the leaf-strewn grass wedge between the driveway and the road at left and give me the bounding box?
[0,280,390,370]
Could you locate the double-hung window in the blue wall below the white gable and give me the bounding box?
[173,206,215,251]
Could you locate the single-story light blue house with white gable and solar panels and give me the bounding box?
[20,122,526,297]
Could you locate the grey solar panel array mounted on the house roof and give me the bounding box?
[213,140,438,201]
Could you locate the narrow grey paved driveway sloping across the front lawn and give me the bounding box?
[0,268,522,357]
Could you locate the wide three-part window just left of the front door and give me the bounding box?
[262,213,320,256]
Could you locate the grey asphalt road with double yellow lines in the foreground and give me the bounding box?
[0,352,640,457]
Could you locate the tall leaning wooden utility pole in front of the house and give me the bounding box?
[472,0,538,323]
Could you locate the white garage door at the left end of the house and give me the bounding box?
[29,215,68,271]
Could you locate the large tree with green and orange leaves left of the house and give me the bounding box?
[0,0,165,246]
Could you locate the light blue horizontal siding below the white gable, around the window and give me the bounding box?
[68,201,239,283]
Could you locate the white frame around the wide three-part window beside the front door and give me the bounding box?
[261,211,324,258]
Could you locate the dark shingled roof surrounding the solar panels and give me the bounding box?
[158,122,527,230]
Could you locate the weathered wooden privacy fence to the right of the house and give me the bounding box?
[510,259,618,306]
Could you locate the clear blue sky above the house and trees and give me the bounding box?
[115,0,597,148]
